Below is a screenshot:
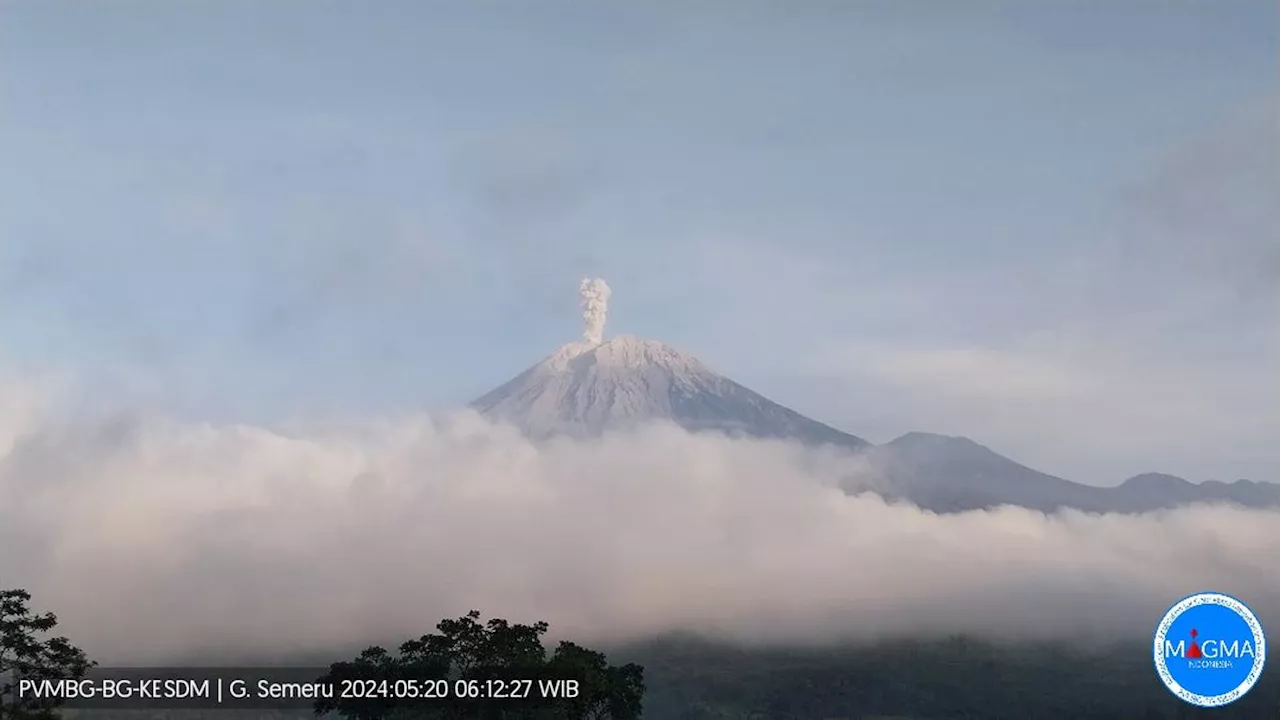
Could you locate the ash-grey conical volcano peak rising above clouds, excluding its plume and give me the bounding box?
[471,336,869,450]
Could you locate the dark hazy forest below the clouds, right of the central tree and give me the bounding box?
[609,638,1280,720]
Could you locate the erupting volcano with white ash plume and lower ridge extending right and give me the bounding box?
[471,279,1280,512]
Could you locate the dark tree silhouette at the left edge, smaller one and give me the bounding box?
[0,589,95,720]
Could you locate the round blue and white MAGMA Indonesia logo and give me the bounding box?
[1152,592,1267,707]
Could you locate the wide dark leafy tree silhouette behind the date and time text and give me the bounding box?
[315,610,645,720]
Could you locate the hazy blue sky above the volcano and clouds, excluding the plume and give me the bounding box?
[0,0,1280,483]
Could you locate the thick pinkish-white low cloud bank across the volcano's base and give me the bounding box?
[0,384,1280,662]
